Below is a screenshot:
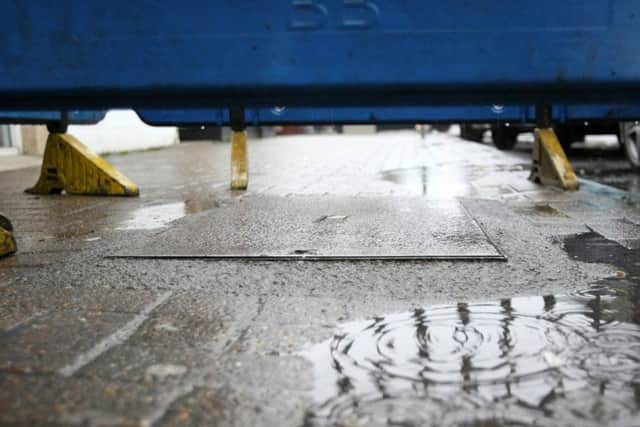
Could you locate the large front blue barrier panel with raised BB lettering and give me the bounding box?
[0,0,640,111]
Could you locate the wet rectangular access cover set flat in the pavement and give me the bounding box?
[113,196,505,261]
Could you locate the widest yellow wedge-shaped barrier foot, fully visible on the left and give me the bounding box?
[26,133,139,196]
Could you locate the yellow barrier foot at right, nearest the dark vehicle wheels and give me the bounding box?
[530,128,578,190]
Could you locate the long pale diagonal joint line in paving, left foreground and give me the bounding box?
[58,291,173,377]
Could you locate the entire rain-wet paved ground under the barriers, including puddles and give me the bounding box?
[0,132,640,427]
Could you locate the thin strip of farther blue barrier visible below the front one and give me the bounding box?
[0,105,640,126]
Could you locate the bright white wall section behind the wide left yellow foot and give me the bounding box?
[69,110,179,153]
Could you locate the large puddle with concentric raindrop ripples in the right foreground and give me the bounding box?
[304,233,640,426]
